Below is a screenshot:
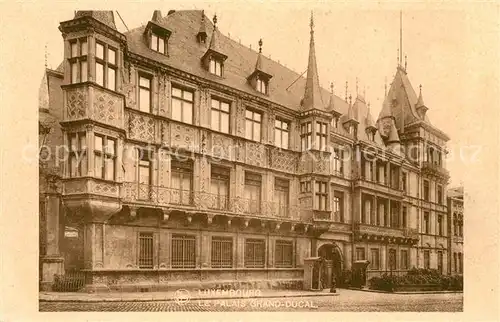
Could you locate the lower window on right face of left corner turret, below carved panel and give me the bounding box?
[94,134,116,180]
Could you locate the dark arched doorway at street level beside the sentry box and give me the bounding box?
[318,243,342,288]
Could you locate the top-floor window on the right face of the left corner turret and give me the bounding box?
[95,42,118,91]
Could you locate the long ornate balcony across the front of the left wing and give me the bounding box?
[120,182,310,220]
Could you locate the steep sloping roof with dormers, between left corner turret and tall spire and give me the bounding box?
[125,10,347,114]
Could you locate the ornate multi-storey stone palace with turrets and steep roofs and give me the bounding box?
[39,10,454,290]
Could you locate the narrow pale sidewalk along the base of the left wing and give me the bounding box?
[38,290,339,302]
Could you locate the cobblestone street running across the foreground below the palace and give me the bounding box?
[39,290,463,312]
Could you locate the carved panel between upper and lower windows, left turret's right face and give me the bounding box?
[93,90,123,127]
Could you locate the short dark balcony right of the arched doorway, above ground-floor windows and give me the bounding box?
[354,223,419,244]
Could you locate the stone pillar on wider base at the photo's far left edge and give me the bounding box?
[39,193,64,291]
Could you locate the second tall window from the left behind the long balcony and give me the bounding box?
[170,160,193,205]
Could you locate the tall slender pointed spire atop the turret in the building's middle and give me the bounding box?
[302,11,324,110]
